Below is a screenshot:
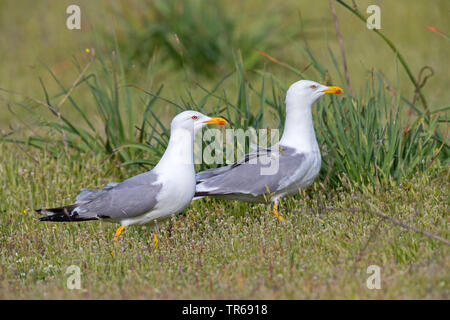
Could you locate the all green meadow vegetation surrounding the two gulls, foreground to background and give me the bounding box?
[0,0,450,299]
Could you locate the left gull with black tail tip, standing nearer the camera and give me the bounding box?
[36,111,226,243]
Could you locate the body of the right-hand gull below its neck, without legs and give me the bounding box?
[194,146,320,202]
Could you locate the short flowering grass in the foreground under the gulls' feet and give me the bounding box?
[0,144,450,299]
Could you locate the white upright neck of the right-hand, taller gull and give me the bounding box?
[280,96,319,152]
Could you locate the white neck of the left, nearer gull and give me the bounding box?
[155,129,195,174]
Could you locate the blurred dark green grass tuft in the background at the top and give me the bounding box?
[110,0,280,78]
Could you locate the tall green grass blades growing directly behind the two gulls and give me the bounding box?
[0,46,444,186]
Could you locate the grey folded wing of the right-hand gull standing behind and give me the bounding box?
[195,147,307,197]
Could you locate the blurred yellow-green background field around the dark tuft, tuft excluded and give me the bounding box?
[0,0,450,121]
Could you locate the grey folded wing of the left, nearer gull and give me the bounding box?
[73,171,162,220]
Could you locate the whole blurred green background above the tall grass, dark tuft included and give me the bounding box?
[0,0,450,130]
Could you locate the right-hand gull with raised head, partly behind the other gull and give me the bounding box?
[194,80,342,220]
